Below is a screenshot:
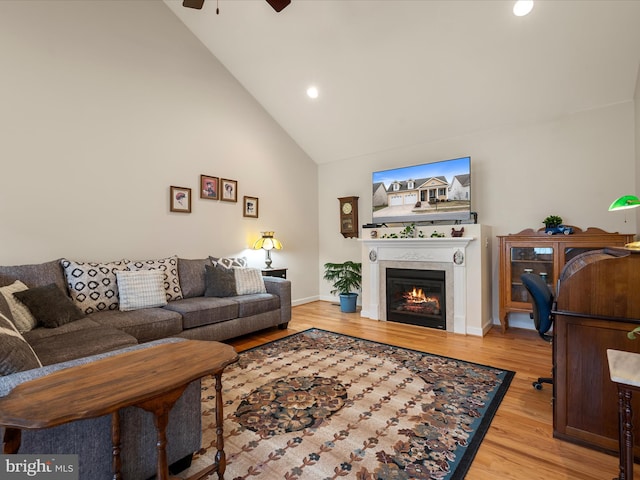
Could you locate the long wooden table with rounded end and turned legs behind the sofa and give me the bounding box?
[0,340,238,480]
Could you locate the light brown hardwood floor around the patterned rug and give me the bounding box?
[229,302,640,480]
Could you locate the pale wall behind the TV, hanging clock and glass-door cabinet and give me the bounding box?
[319,102,637,323]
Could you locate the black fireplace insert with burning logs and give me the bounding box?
[385,268,447,330]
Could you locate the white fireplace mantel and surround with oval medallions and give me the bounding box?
[361,225,491,335]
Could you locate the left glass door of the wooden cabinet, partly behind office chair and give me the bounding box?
[510,247,554,303]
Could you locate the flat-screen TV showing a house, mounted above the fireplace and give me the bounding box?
[371,157,471,224]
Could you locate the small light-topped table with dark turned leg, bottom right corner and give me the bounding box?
[607,349,640,480]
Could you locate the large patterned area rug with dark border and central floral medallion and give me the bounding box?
[179,329,514,480]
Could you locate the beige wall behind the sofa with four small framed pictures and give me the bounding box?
[0,0,319,301]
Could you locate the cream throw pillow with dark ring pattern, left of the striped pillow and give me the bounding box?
[61,258,129,315]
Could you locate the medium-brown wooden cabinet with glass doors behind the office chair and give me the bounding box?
[498,227,633,332]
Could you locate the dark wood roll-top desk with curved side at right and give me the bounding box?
[553,249,640,458]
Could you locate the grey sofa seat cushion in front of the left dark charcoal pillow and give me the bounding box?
[27,325,138,365]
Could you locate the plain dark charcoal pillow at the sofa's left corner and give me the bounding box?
[13,283,85,328]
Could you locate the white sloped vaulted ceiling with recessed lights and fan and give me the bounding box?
[165,0,640,164]
